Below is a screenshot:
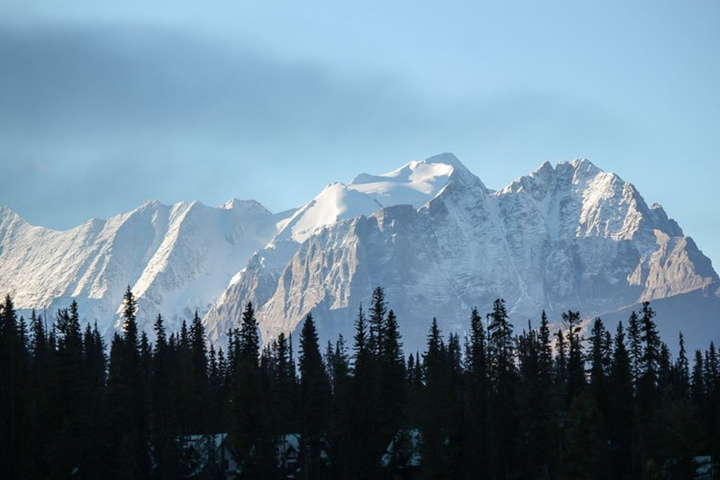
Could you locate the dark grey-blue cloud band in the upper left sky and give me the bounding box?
[0,21,430,141]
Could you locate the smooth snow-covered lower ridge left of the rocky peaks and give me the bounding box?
[0,200,281,333]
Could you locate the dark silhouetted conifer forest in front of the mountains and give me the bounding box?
[0,288,720,479]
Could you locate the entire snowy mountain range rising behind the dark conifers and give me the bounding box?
[0,154,720,352]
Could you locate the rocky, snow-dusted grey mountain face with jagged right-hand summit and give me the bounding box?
[206,159,720,350]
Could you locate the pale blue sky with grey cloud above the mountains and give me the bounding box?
[0,0,720,268]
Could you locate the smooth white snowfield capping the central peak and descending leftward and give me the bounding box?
[204,153,488,341]
